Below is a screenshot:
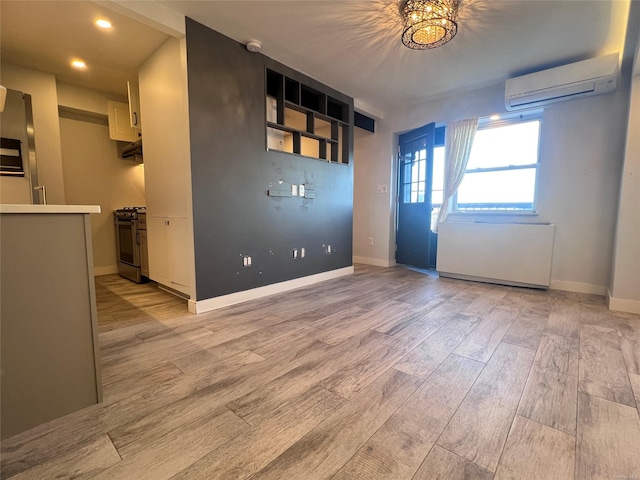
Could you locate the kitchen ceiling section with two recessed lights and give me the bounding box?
[0,0,168,95]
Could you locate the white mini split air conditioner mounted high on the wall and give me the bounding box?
[504,53,618,110]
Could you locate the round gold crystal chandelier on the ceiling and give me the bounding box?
[399,0,458,50]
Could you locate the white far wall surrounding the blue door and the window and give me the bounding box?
[354,73,629,295]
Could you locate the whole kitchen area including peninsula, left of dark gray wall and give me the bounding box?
[0,2,194,438]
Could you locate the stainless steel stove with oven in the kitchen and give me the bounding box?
[113,207,149,283]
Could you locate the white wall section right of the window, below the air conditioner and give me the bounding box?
[538,87,628,295]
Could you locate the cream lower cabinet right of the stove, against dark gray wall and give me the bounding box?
[147,216,191,295]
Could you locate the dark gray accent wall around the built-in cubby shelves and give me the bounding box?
[186,18,353,300]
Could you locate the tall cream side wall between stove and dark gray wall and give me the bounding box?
[138,38,196,300]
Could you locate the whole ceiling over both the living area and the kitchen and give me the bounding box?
[0,0,630,116]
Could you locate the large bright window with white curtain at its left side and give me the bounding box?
[456,111,542,212]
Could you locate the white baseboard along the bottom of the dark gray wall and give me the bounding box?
[189,266,353,313]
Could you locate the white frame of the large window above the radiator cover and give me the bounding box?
[450,109,543,215]
